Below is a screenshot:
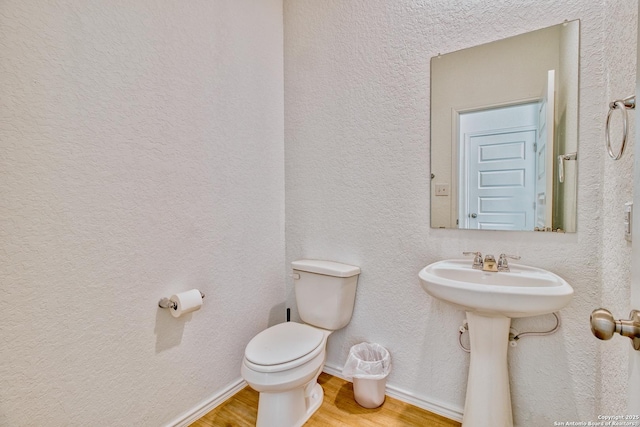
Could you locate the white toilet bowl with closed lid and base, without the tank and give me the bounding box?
[241,322,331,427]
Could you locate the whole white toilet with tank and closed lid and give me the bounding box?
[241,260,360,427]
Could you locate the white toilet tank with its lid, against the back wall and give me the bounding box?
[291,259,360,331]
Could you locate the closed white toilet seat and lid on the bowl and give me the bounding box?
[244,322,325,372]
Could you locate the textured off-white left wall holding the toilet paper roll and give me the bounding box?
[0,0,285,426]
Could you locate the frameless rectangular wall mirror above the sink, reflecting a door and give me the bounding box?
[431,20,580,232]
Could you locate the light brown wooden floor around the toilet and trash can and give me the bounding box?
[191,372,460,427]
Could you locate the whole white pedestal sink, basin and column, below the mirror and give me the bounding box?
[419,259,573,427]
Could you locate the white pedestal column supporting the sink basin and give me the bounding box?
[462,311,513,427]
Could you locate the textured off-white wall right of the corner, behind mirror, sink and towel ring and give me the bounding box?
[285,0,637,426]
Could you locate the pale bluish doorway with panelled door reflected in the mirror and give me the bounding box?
[458,102,538,230]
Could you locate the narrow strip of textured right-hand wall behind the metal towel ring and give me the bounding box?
[598,1,640,413]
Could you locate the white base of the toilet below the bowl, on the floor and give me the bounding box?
[256,382,324,427]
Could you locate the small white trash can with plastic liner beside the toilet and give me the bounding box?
[342,342,391,408]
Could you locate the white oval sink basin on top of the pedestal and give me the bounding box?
[419,259,573,318]
